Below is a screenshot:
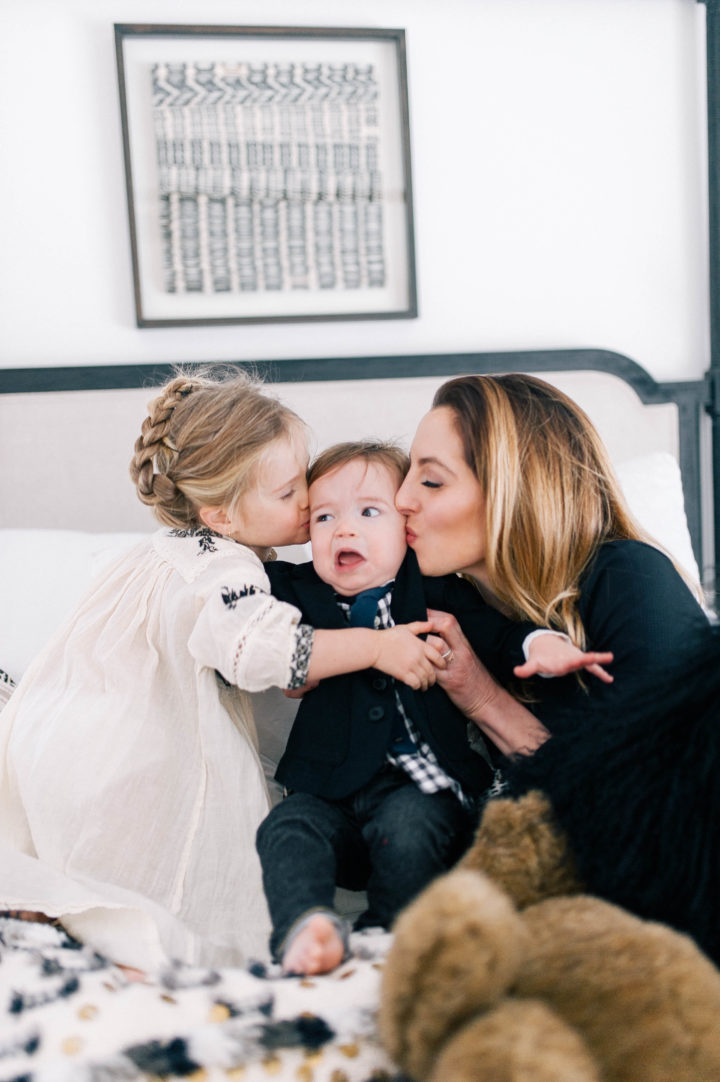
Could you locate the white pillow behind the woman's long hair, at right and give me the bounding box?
[615,451,699,581]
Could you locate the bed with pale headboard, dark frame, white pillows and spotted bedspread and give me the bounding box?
[0,349,714,1082]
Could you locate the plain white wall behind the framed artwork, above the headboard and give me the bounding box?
[0,0,709,379]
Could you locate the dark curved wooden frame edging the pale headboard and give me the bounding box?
[0,349,705,589]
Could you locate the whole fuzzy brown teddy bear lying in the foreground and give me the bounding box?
[380,791,720,1082]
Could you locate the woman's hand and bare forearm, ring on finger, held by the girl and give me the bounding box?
[428,609,549,755]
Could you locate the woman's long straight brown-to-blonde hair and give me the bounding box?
[433,373,655,645]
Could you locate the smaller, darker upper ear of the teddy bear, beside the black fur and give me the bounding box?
[458,790,581,909]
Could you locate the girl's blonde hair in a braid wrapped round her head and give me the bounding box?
[130,368,304,529]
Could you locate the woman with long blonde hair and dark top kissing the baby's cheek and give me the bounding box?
[397,374,709,755]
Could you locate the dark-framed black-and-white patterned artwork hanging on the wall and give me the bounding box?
[115,24,417,327]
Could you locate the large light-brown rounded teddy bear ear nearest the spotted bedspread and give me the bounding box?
[379,871,527,1082]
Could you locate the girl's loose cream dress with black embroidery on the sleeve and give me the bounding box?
[0,529,301,968]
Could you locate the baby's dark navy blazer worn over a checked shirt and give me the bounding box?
[265,550,533,800]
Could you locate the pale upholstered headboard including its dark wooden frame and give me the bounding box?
[0,349,711,578]
